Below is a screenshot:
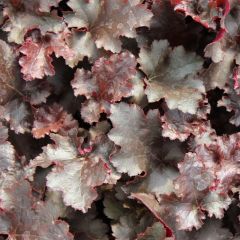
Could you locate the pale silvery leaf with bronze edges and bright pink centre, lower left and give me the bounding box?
[28,129,119,212]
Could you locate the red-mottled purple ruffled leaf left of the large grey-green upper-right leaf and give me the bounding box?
[71,52,141,123]
